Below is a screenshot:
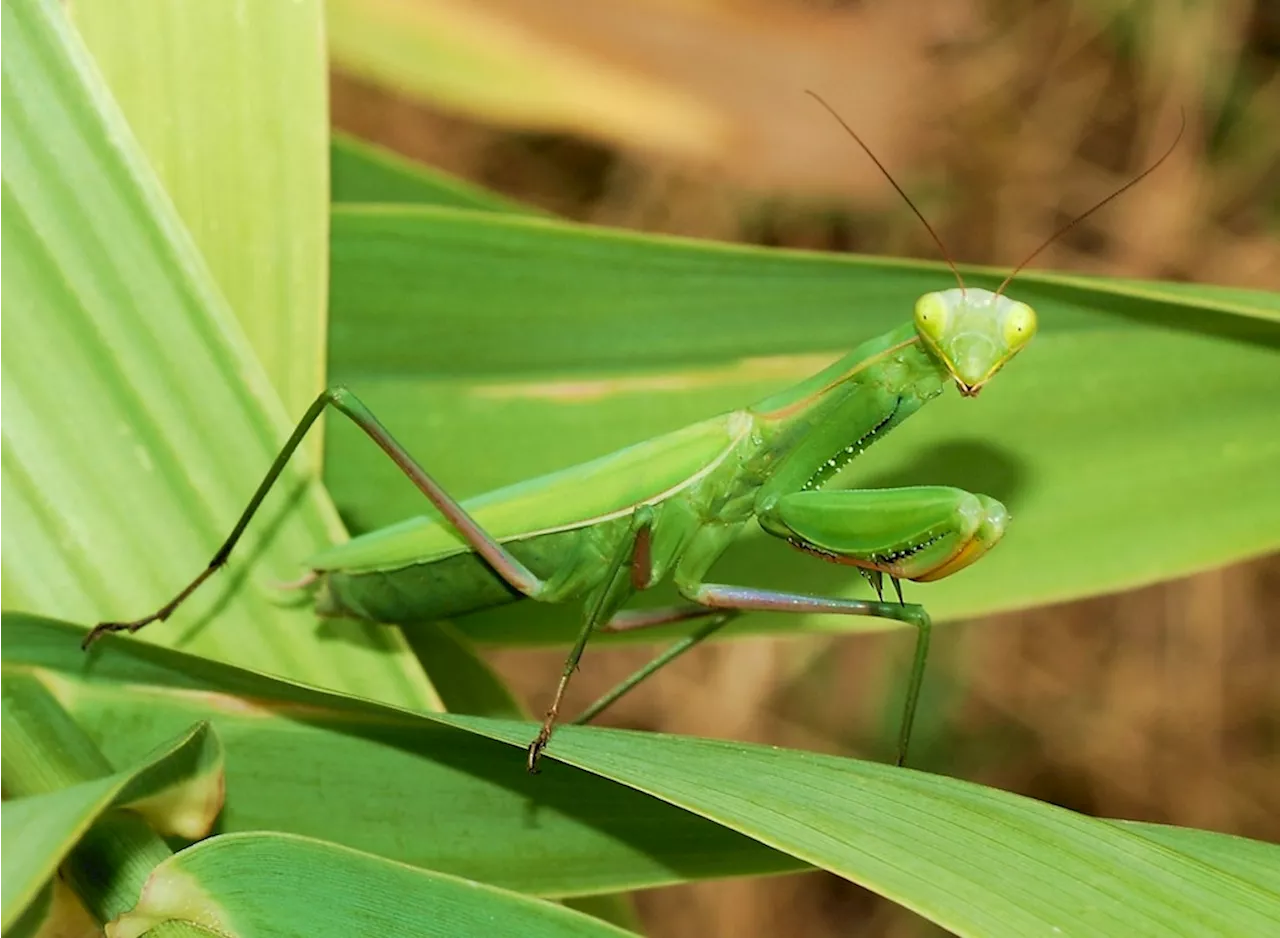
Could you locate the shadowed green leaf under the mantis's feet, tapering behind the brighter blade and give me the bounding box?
[0,613,803,897]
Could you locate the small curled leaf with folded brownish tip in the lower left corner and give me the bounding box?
[0,724,221,934]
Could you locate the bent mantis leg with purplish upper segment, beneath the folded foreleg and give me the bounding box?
[687,584,933,765]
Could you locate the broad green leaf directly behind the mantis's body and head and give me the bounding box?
[325,207,1280,642]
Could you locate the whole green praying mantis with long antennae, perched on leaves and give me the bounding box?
[83,92,1181,773]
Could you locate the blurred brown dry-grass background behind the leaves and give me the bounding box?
[333,0,1280,938]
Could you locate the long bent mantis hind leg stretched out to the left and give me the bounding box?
[81,386,547,648]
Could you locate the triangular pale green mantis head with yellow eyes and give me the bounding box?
[915,287,1036,397]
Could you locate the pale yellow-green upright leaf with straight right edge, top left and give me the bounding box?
[69,0,329,427]
